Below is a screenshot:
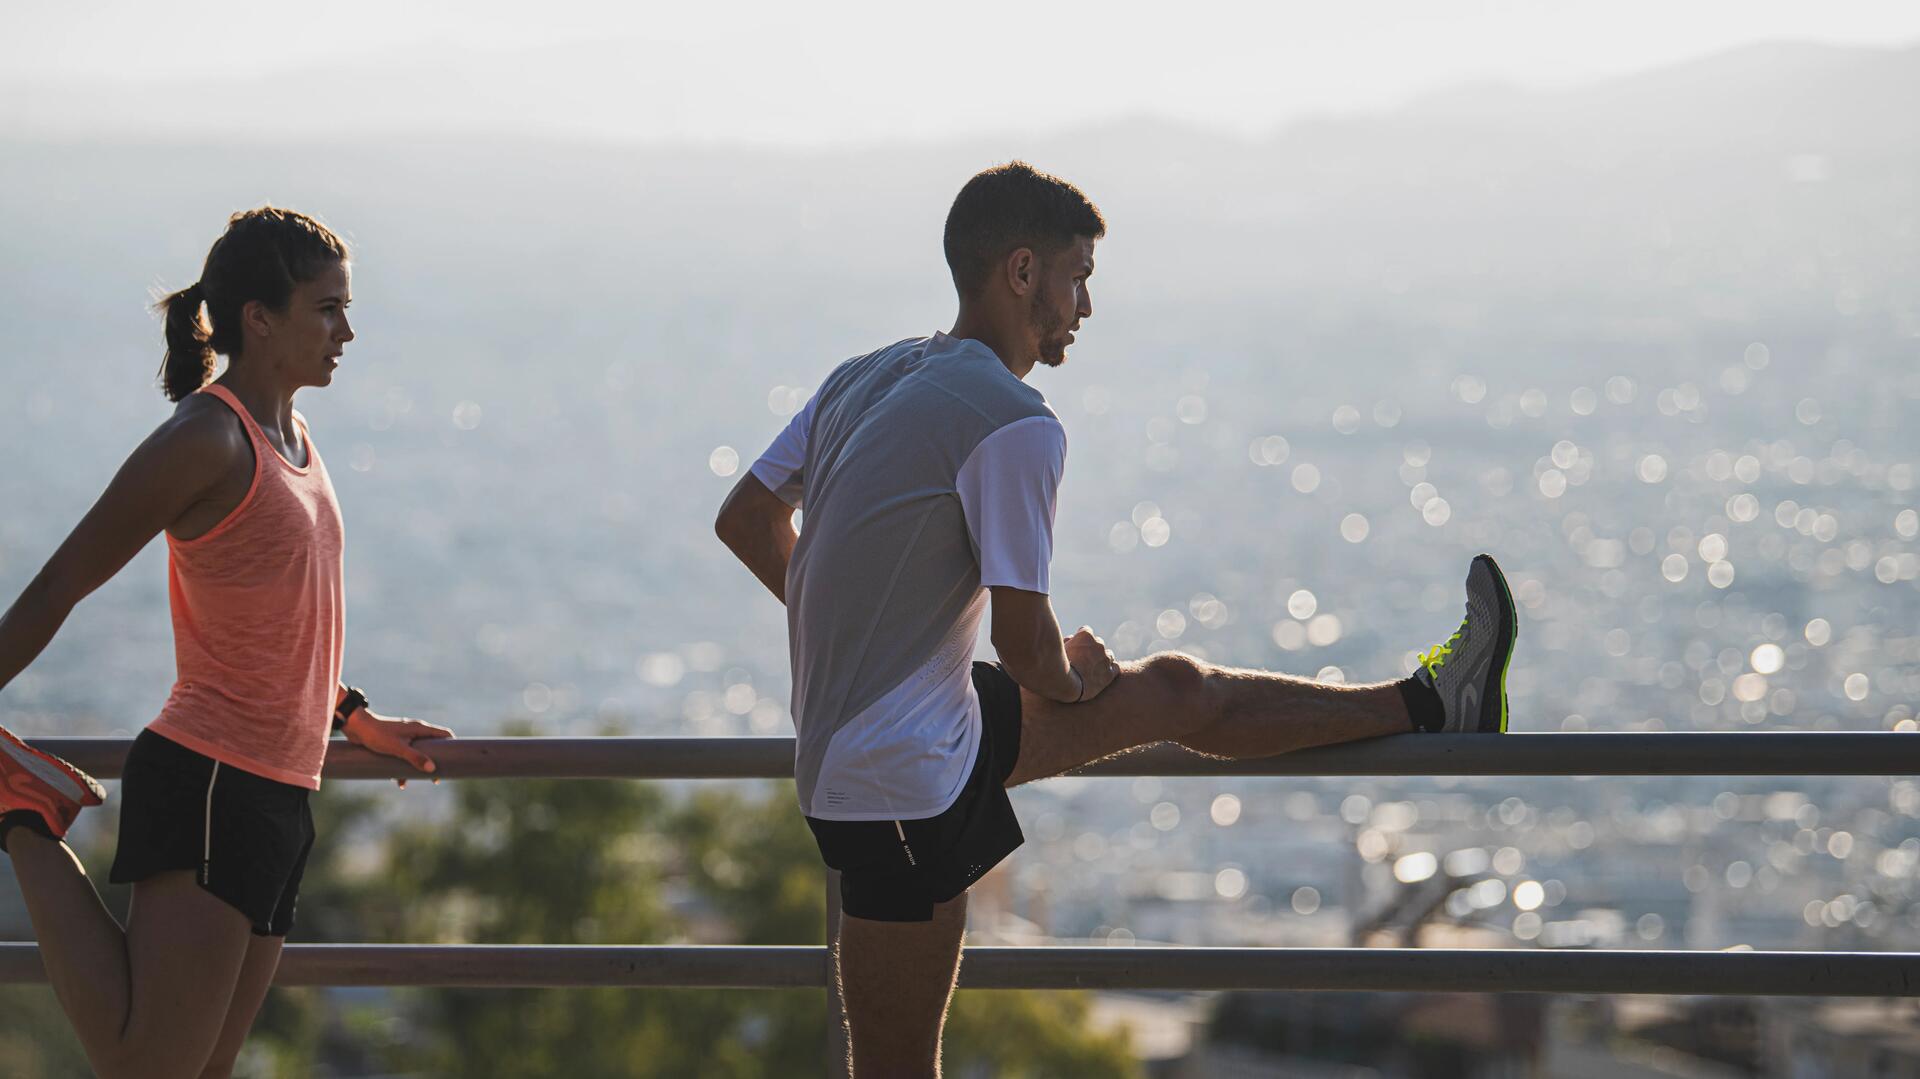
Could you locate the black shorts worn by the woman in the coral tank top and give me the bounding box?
[108,730,313,937]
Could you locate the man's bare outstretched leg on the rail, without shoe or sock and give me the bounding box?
[1006,653,1413,787]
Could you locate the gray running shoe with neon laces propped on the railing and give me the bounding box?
[1413,555,1521,733]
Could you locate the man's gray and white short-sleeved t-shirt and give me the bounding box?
[753,334,1066,820]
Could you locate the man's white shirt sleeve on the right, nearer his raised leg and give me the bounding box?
[954,417,1068,593]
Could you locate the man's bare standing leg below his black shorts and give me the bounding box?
[833,893,966,1079]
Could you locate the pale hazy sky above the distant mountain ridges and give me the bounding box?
[0,0,1920,144]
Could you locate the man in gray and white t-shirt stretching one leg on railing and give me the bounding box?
[716,161,1517,1077]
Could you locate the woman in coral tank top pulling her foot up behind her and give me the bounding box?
[0,205,453,1077]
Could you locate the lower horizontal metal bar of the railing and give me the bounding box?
[0,945,1920,996]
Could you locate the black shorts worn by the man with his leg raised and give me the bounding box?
[806,662,1025,922]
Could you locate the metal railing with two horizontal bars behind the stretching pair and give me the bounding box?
[11,731,1920,996]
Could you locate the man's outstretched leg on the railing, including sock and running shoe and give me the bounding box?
[1006,555,1515,787]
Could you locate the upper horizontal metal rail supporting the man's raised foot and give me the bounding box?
[33,731,1920,779]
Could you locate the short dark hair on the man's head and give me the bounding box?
[947,161,1106,296]
